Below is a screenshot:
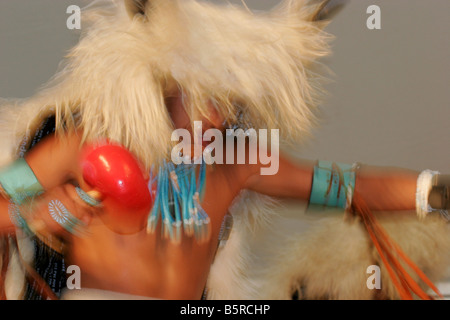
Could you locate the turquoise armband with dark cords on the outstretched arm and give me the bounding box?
[309,161,356,209]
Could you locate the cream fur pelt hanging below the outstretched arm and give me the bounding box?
[208,202,450,300]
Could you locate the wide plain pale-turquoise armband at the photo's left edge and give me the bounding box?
[0,158,44,205]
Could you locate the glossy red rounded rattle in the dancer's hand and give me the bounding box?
[80,142,153,234]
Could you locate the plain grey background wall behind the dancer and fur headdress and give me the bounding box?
[0,0,450,294]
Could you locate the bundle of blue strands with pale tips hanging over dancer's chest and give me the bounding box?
[147,161,211,243]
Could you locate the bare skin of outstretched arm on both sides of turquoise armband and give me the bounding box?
[245,155,432,211]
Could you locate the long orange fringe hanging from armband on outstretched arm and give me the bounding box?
[352,192,443,300]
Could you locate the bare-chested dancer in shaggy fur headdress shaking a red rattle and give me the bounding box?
[0,1,449,299]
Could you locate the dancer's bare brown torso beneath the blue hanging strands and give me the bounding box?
[66,164,243,299]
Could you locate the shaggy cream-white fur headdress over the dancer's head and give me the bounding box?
[7,0,329,166]
